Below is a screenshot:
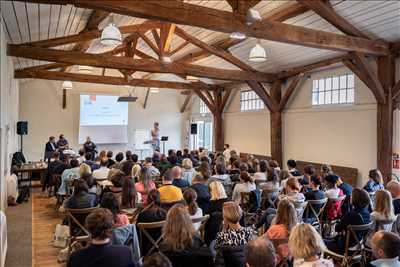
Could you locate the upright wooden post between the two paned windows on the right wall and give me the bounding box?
[270,80,283,166]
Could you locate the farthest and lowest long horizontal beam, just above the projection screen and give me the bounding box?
[14,70,212,90]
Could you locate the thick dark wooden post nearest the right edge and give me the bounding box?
[377,55,396,182]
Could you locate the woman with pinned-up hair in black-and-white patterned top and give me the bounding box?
[215,201,257,249]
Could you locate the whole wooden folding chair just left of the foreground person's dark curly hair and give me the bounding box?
[65,207,97,255]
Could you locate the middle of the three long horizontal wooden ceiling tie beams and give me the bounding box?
[7,44,275,82]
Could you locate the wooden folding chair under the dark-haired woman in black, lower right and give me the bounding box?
[324,222,373,267]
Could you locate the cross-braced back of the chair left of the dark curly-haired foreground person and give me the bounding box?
[65,207,97,237]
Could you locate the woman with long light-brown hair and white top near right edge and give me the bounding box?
[371,189,396,231]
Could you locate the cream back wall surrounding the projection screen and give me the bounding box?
[20,80,183,161]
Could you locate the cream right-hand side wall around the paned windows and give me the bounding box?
[187,64,390,184]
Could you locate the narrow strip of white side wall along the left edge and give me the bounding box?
[0,18,19,213]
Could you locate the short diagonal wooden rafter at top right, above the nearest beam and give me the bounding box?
[297,0,369,39]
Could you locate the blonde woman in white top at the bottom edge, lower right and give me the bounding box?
[289,224,334,267]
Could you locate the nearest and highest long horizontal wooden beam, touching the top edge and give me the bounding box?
[72,0,389,55]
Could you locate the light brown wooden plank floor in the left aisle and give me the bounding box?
[32,193,64,267]
